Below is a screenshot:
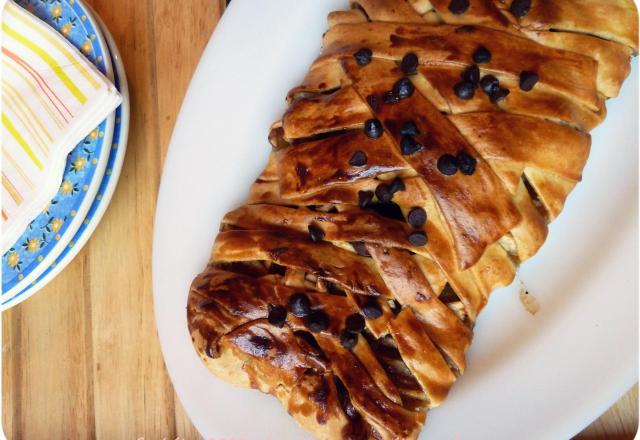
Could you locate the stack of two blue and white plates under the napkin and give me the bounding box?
[0,0,129,310]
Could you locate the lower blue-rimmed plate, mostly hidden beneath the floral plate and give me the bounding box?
[1,9,129,310]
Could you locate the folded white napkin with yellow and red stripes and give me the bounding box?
[1,0,121,253]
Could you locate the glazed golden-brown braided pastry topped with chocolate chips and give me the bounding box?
[187,0,638,439]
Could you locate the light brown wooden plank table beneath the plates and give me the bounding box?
[2,0,638,440]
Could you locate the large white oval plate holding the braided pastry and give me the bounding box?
[153,0,638,440]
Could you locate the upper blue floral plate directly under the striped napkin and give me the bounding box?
[2,0,116,300]
